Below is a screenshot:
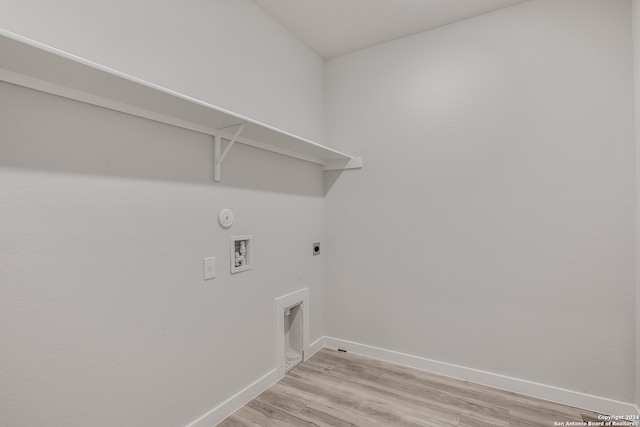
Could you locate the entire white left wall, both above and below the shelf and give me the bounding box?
[0,0,324,427]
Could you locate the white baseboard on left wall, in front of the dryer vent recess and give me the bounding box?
[186,369,284,427]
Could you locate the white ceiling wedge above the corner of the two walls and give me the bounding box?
[253,0,526,59]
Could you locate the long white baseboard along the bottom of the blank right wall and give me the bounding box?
[324,337,640,415]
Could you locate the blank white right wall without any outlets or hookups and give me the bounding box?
[325,0,635,402]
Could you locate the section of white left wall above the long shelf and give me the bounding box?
[0,0,324,143]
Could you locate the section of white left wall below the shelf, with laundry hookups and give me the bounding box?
[0,83,324,427]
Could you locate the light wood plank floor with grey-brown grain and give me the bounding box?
[219,349,598,427]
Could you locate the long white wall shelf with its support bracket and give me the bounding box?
[0,30,362,176]
